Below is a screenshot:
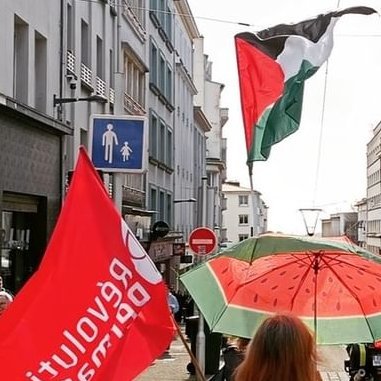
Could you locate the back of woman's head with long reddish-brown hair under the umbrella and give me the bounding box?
[235,315,316,381]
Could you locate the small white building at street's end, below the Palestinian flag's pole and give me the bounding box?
[222,181,268,245]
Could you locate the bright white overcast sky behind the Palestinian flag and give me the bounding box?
[188,0,381,234]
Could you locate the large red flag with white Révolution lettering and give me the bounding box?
[0,148,174,381]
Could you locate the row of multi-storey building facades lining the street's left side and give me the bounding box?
[0,0,227,291]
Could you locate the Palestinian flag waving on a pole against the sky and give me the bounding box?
[235,7,376,166]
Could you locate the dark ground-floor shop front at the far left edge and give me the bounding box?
[0,99,71,293]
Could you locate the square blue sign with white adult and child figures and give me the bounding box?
[89,114,147,173]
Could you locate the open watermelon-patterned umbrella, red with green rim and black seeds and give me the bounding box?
[180,234,381,344]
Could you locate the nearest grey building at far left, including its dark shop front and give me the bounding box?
[0,0,72,292]
